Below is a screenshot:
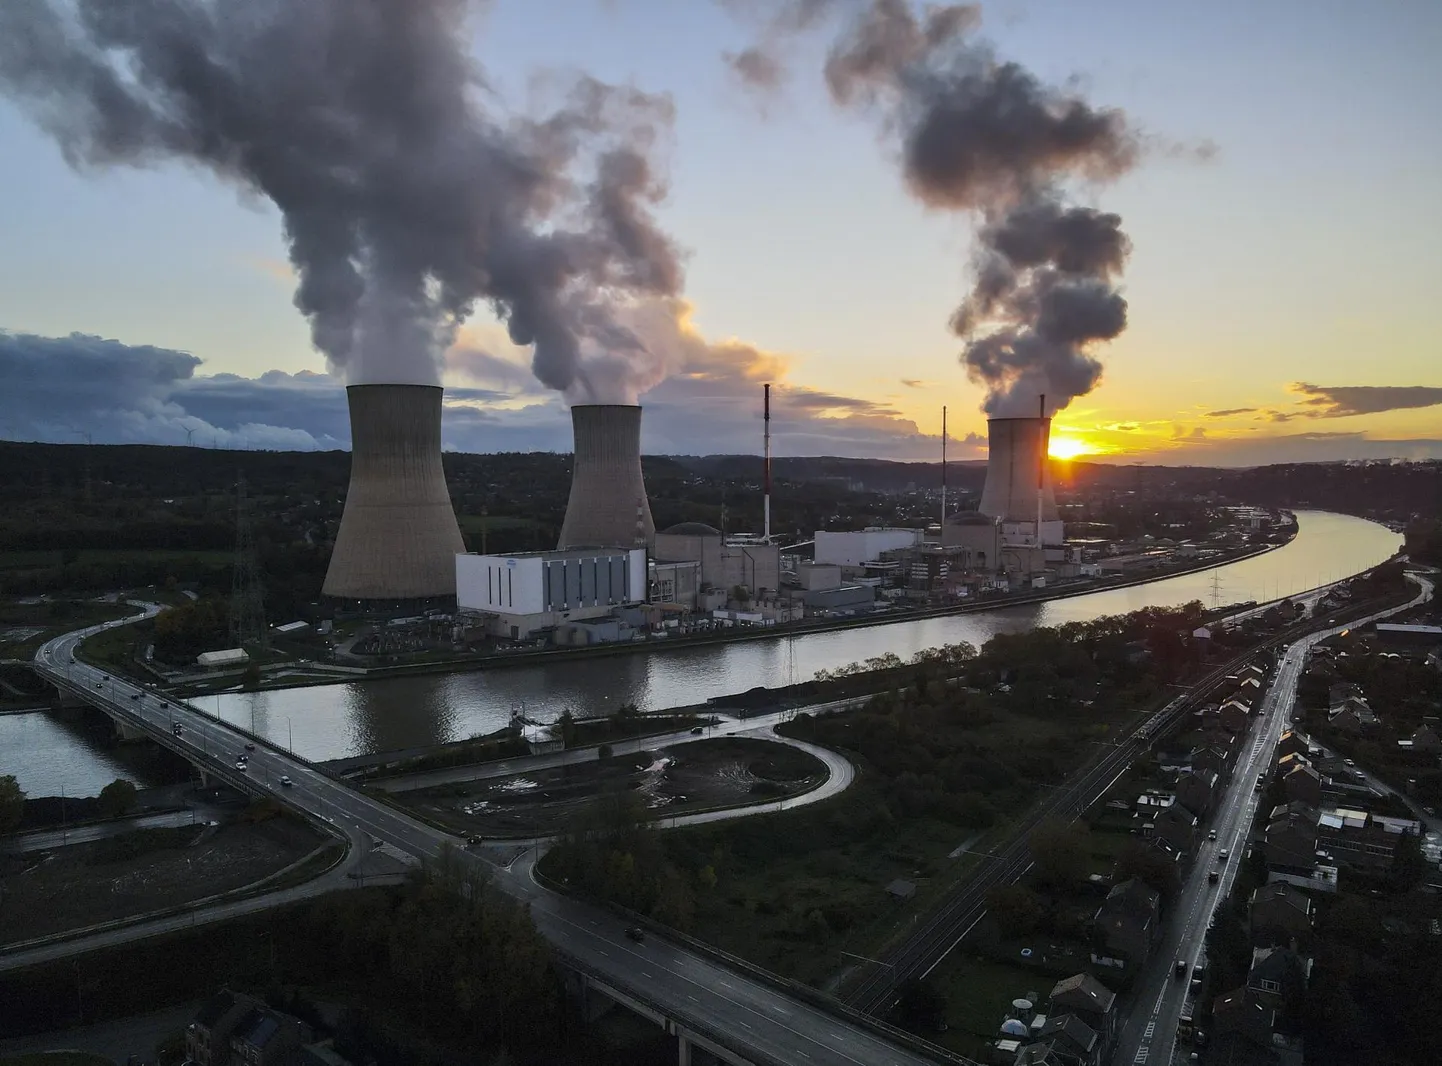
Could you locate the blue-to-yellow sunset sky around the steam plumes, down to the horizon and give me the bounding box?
[0,0,1442,466]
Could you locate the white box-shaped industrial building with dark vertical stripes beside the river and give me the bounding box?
[456,548,647,640]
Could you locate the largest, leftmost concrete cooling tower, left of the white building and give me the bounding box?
[322,385,466,600]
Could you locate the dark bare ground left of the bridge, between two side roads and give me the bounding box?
[0,816,323,945]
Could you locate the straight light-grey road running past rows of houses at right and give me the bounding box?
[1113,578,1432,1066]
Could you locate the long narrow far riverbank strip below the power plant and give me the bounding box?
[163,536,1299,700]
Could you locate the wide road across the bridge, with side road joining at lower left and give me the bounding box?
[19,609,957,1066]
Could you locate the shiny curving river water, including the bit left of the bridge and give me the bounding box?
[0,511,1402,795]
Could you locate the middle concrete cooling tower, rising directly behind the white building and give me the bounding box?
[557,404,656,548]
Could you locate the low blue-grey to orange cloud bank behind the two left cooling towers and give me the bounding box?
[0,321,986,459]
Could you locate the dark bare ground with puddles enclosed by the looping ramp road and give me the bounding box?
[392,737,826,837]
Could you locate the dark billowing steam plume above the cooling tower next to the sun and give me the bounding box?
[732,0,1139,414]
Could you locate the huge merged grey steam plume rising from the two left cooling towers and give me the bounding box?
[0,0,682,401]
